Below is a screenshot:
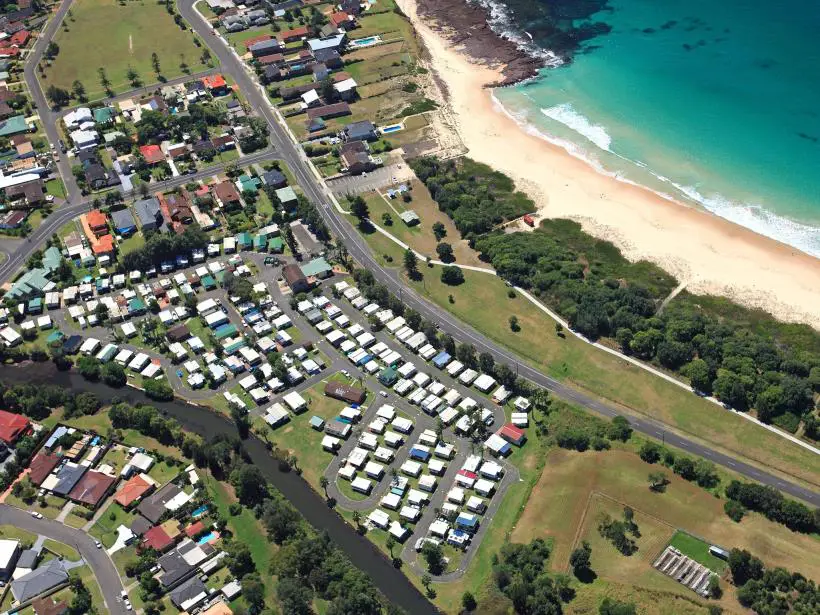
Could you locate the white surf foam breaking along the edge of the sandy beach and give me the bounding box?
[492,94,820,258]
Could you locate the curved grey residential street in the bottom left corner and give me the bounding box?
[0,504,127,615]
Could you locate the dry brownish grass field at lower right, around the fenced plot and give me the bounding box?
[512,450,820,578]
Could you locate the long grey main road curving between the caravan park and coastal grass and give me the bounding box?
[178,0,820,507]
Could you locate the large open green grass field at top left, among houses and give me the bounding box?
[41,0,206,100]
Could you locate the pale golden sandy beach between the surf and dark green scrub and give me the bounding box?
[397,0,820,329]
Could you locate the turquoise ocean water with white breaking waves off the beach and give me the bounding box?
[486,0,820,257]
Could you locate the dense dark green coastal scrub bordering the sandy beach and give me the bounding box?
[412,158,820,440]
